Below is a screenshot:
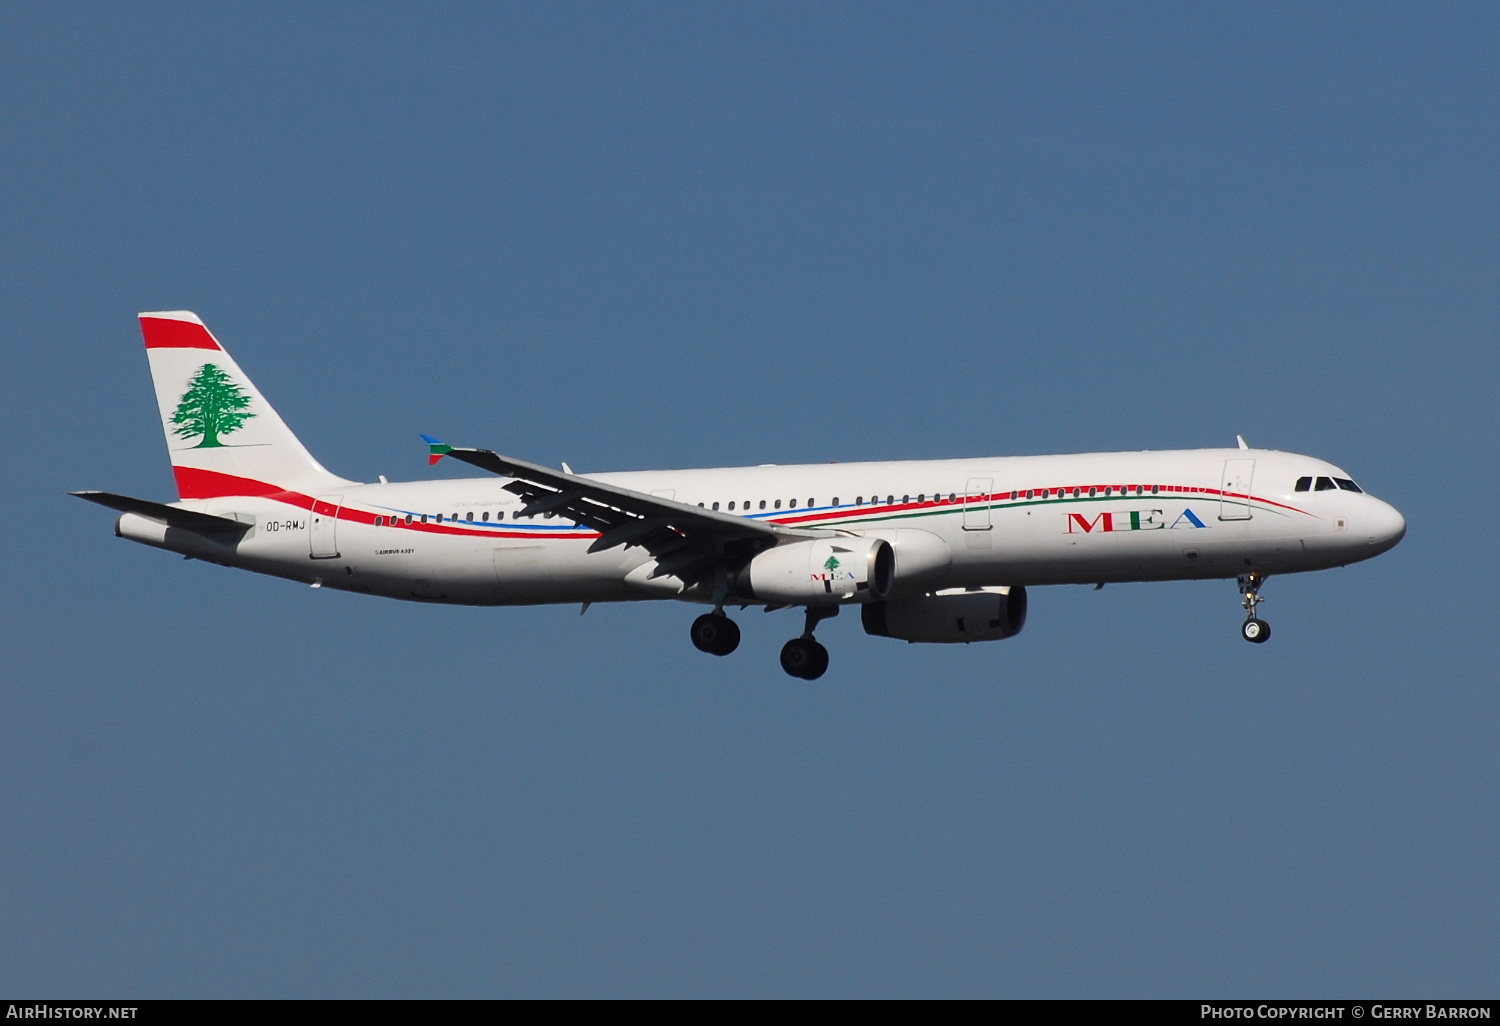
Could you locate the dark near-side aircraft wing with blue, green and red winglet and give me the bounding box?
[428,438,824,584]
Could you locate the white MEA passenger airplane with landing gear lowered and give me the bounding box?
[72,311,1406,681]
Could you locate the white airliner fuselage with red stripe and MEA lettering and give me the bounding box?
[117,449,1406,606]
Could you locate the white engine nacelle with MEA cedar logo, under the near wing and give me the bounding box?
[735,539,896,606]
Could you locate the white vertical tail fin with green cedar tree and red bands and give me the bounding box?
[141,311,353,500]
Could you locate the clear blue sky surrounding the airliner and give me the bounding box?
[0,3,1500,996]
